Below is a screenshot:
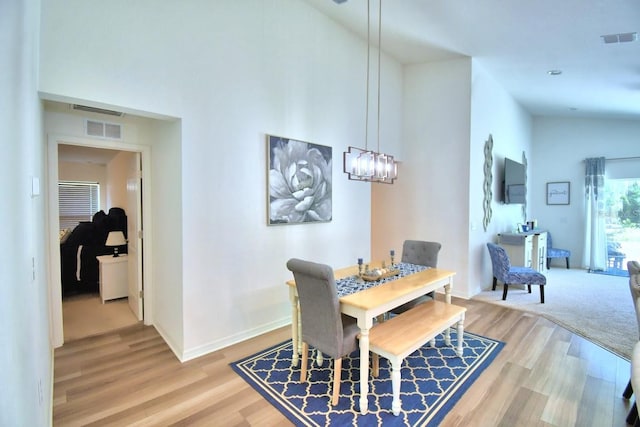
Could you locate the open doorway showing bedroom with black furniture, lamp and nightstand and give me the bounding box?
[58,143,143,342]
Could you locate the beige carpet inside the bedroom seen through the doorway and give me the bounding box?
[62,294,138,341]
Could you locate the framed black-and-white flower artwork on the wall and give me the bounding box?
[267,135,332,225]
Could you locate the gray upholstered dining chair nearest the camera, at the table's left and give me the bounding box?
[287,258,360,406]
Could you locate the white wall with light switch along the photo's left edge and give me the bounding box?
[0,0,51,426]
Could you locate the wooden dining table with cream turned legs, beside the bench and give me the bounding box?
[287,262,455,414]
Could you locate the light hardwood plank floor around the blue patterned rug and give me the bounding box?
[53,298,632,427]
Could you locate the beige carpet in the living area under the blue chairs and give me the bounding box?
[472,267,638,360]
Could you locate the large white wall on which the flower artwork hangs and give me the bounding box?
[40,0,401,358]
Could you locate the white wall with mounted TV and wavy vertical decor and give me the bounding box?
[468,59,538,296]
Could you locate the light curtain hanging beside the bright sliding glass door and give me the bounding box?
[582,157,607,271]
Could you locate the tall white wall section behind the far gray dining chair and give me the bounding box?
[371,58,471,296]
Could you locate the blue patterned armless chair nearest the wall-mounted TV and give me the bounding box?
[487,243,547,304]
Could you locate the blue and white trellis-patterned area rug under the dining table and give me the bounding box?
[231,330,504,426]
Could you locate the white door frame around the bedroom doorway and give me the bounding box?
[47,134,153,348]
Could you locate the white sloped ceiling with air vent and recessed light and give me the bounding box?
[304,0,640,119]
